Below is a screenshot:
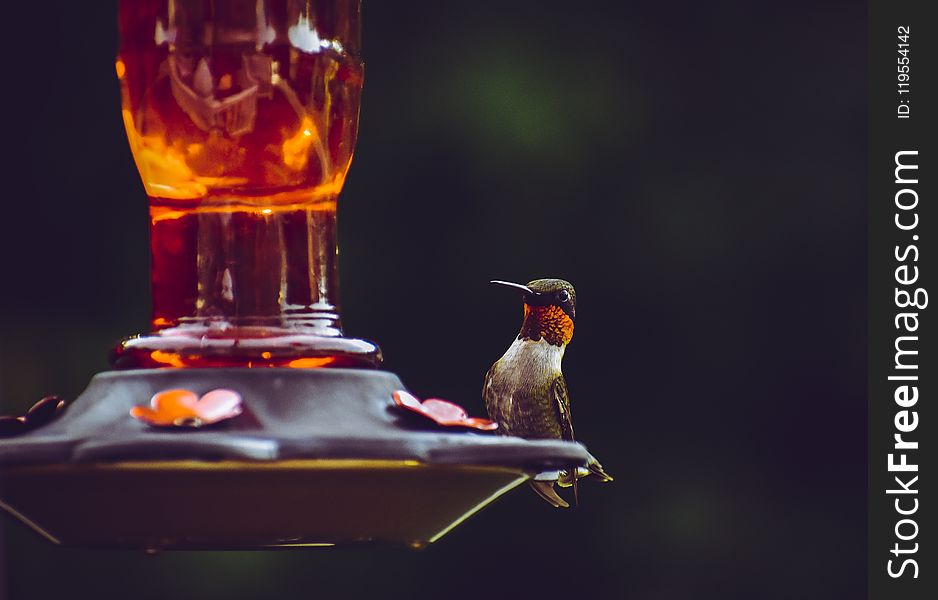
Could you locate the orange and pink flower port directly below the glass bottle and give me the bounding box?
[130,389,241,427]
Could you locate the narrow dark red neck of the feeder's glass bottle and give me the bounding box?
[144,199,342,336]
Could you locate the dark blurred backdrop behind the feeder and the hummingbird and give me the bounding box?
[0,0,866,600]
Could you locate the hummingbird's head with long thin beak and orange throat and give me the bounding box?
[491,279,576,347]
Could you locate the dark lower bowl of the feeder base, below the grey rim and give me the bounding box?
[0,460,527,550]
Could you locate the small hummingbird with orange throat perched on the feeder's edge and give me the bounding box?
[482,279,612,508]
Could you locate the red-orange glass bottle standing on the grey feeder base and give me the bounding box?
[115,0,379,366]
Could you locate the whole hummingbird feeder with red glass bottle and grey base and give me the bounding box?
[0,0,589,550]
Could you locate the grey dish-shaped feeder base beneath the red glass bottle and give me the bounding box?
[0,368,589,550]
